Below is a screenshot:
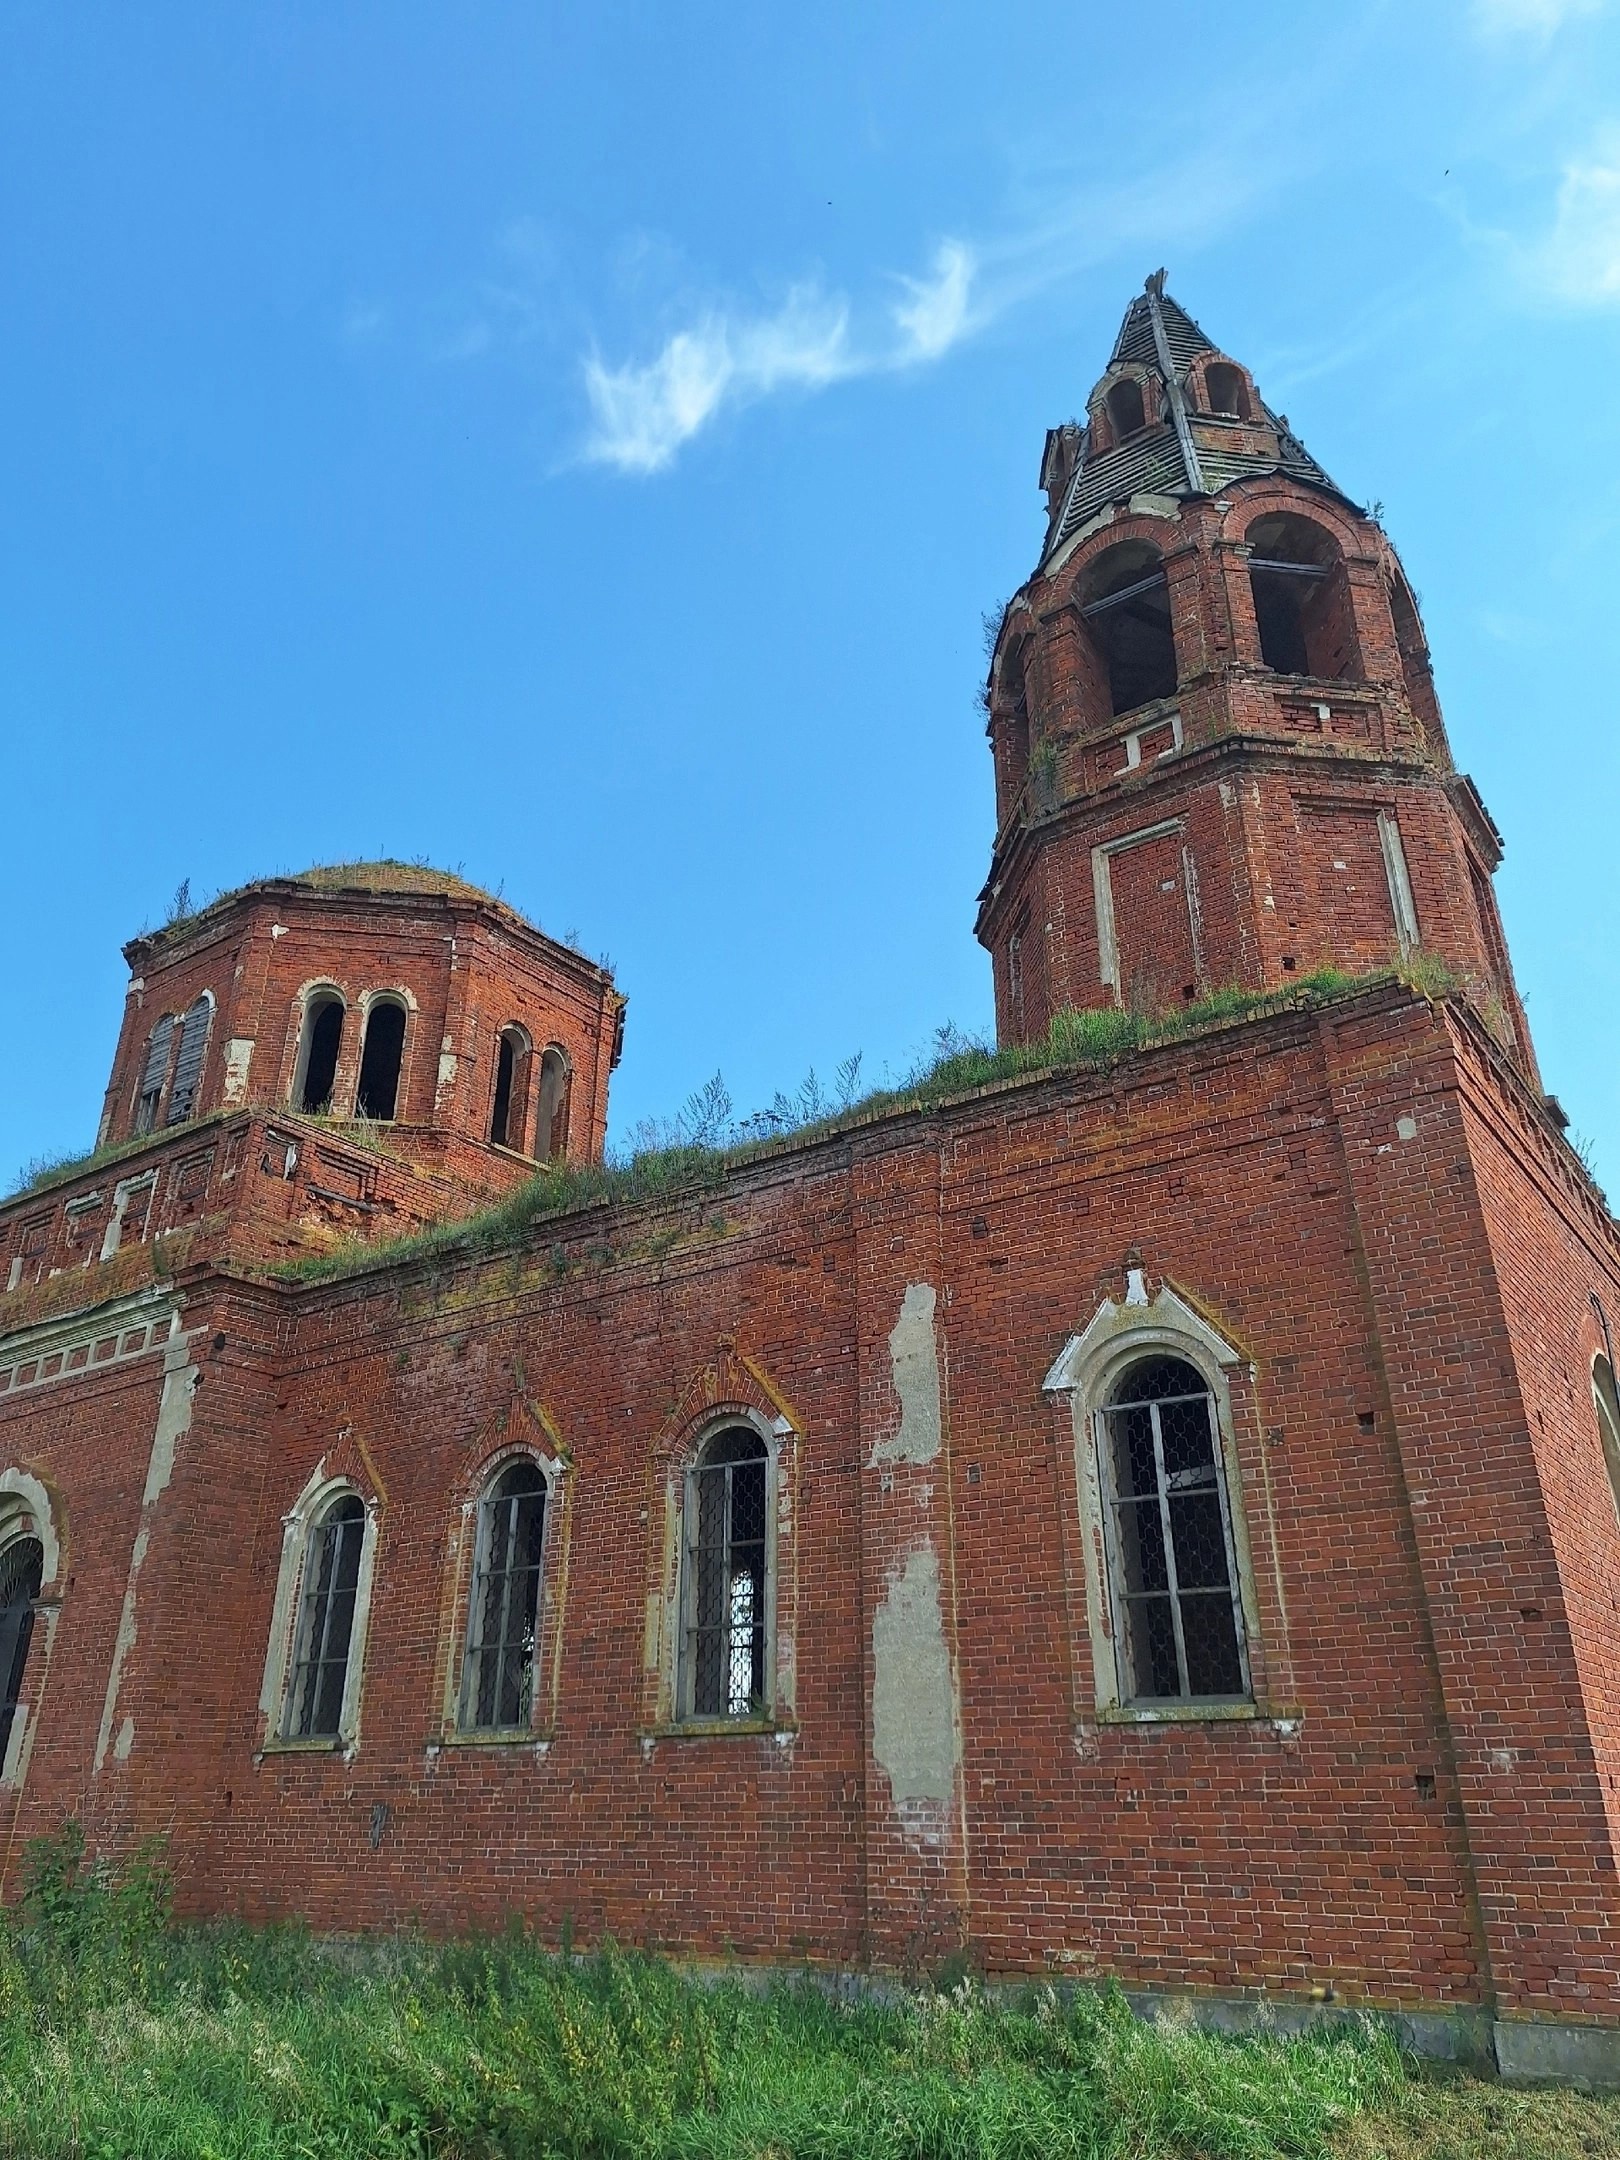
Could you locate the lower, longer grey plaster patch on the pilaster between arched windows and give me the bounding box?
[873,1544,961,1842]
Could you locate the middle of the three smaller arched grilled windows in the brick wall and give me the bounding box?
[460,1462,546,1732]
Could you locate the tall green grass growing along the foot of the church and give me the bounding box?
[0,1830,1620,2160]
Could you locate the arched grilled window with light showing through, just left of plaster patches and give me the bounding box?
[680,1426,771,1717]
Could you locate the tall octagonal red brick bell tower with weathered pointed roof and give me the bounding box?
[976,270,1534,1080]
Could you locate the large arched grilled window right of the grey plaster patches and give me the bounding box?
[1097,1356,1248,1702]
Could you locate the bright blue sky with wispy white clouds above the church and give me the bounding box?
[0,0,1620,1192]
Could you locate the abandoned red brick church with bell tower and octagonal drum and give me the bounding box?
[0,279,1620,2078]
